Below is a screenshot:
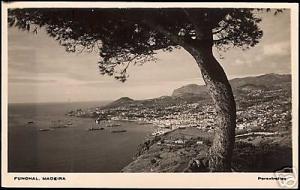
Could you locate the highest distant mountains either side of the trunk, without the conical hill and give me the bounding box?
[172,73,291,97]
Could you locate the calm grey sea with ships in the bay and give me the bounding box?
[8,102,155,173]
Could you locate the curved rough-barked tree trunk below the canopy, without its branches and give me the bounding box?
[188,44,236,172]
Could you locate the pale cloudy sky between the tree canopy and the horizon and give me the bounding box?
[8,10,291,103]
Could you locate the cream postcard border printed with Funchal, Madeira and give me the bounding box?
[1,2,299,188]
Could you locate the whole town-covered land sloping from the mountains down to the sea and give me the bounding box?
[68,74,292,172]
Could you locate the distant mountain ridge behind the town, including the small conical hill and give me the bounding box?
[103,74,291,109]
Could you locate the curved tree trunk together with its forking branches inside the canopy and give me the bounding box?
[146,15,236,172]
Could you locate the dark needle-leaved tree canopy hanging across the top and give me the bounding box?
[8,8,276,82]
